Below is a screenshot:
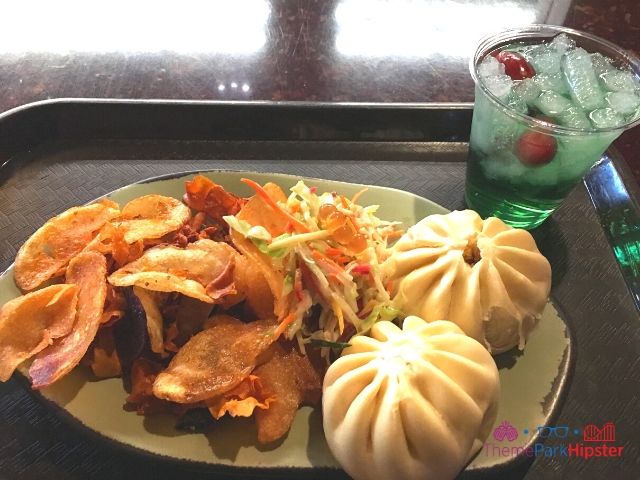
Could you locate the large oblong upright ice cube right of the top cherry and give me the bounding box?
[562,48,605,111]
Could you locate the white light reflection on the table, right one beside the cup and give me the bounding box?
[335,0,540,58]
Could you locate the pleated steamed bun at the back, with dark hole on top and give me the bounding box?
[383,210,551,353]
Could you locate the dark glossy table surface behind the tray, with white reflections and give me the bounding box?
[0,0,640,478]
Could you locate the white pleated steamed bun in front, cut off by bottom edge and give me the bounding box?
[322,317,500,480]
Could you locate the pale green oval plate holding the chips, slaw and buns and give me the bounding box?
[0,171,572,475]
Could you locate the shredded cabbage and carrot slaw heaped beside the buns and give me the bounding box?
[223,179,402,358]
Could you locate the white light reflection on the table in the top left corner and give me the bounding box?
[0,0,271,56]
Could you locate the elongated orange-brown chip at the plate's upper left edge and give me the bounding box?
[14,199,120,290]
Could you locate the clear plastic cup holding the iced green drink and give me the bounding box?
[465,25,640,229]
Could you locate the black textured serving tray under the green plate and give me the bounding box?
[0,100,640,479]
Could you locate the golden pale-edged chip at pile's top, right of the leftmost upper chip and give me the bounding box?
[113,195,191,244]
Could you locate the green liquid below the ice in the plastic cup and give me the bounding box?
[465,83,621,229]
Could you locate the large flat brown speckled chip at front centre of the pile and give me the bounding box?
[153,315,274,403]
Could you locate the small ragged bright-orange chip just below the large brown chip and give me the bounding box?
[206,375,275,420]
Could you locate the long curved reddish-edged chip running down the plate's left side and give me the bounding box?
[29,252,107,388]
